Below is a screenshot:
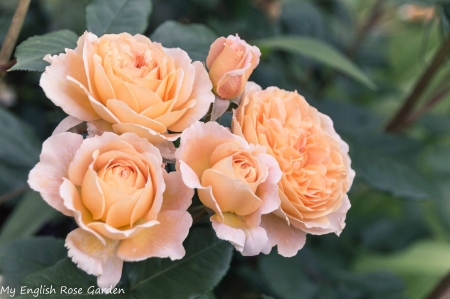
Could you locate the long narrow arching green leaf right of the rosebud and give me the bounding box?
[252,36,376,89]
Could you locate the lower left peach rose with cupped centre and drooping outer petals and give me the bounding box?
[28,132,193,288]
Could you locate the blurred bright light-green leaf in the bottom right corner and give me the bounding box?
[354,241,450,299]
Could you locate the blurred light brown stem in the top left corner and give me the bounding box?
[0,0,31,78]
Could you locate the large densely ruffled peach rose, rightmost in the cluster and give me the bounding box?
[232,84,355,256]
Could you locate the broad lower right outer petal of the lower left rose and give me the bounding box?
[117,211,192,261]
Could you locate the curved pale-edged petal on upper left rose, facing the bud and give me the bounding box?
[168,61,214,132]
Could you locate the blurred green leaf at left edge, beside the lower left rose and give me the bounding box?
[0,190,59,245]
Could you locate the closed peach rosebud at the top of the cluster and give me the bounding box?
[206,34,261,100]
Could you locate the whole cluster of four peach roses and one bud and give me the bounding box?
[28,32,355,287]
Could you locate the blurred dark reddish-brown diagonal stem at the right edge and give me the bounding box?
[385,34,450,133]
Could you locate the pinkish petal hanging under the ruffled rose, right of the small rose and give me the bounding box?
[261,214,306,257]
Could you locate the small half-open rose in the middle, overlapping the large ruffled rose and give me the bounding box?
[175,122,281,256]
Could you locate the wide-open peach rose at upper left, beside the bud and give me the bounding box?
[40,32,214,143]
